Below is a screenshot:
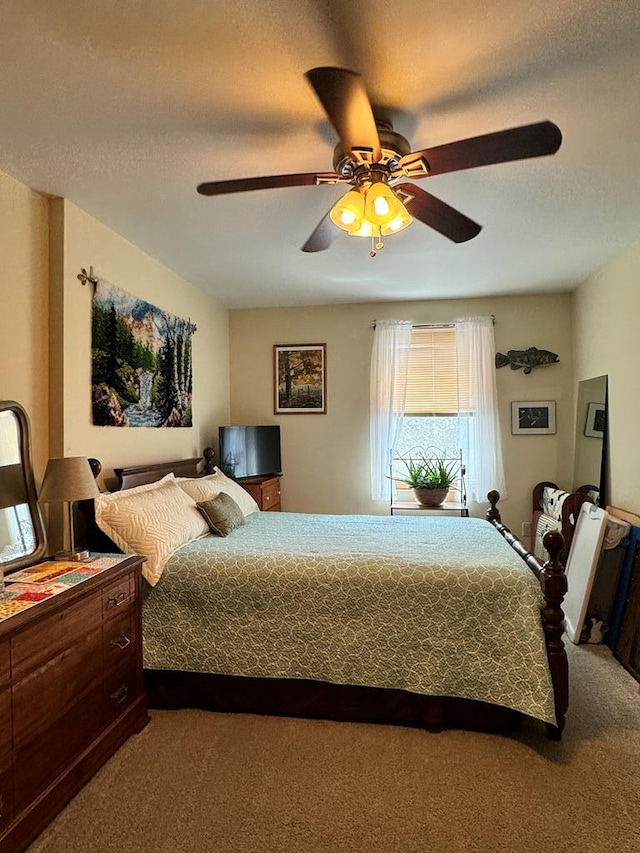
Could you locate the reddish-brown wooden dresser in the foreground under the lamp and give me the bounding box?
[0,557,149,853]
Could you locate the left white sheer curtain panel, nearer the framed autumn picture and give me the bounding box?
[369,320,412,500]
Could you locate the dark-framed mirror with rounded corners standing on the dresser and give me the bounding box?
[0,400,47,574]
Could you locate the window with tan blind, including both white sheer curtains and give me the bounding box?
[370,317,506,501]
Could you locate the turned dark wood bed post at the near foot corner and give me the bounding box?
[540,530,569,740]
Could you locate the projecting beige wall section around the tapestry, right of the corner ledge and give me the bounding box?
[51,199,229,486]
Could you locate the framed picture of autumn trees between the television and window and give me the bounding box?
[273,344,327,415]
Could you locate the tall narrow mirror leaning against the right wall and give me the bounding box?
[573,376,607,506]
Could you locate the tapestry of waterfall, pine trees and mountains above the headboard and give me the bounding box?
[91,279,196,427]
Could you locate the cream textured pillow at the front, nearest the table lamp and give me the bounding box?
[95,474,210,586]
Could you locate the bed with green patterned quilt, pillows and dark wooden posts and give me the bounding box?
[82,451,568,739]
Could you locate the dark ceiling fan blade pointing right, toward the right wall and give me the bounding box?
[400,121,562,178]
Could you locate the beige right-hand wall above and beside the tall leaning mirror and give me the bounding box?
[573,243,640,513]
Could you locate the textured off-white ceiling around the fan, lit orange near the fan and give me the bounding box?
[0,0,640,307]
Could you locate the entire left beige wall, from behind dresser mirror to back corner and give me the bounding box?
[0,165,229,506]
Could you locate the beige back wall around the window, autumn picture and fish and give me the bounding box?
[230,294,573,534]
